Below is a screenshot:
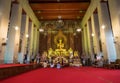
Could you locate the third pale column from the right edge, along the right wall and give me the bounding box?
[91,14,100,55]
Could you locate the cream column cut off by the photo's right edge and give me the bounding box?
[108,0,120,59]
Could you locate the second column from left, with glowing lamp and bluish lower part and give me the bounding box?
[5,4,22,63]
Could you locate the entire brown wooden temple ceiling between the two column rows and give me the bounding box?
[29,0,90,21]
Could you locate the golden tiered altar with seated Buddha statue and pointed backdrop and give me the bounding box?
[39,30,81,65]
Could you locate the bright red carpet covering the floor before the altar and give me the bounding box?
[0,67,120,83]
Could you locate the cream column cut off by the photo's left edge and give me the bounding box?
[0,0,11,63]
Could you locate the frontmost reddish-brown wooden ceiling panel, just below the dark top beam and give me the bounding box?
[30,3,89,10]
